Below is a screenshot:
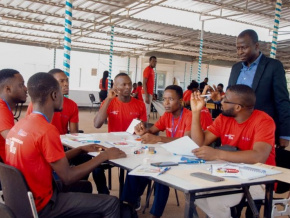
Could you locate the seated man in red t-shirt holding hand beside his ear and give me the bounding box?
[94,73,147,132]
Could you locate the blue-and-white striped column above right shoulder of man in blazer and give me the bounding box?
[270,0,282,58]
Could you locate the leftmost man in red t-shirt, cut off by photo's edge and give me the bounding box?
[0,69,27,162]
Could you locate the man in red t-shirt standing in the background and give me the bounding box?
[143,56,157,116]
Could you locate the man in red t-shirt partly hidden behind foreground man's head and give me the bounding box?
[26,69,79,135]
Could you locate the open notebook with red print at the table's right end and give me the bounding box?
[211,163,281,180]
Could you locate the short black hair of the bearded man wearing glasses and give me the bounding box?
[227,84,256,108]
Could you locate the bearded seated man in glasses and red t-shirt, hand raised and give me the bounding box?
[191,85,275,217]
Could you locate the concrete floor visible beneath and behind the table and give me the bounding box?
[20,108,288,218]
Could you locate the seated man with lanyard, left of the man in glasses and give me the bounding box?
[122,85,211,217]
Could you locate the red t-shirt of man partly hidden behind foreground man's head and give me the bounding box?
[26,97,79,135]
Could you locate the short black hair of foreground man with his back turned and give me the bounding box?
[27,72,59,105]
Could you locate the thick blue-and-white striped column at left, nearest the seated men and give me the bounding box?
[63,0,72,77]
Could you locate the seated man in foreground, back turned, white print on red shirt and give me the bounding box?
[6,73,126,218]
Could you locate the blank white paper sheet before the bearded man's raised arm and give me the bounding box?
[161,136,199,157]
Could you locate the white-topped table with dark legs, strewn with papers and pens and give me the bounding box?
[61,133,280,217]
